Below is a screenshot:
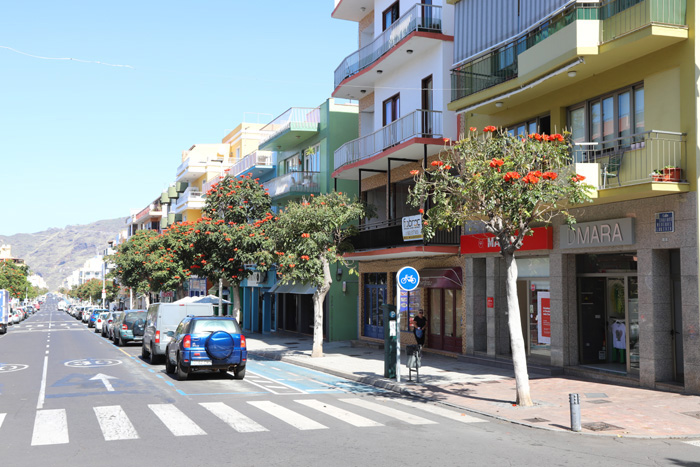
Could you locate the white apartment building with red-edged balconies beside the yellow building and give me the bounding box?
[332,0,464,353]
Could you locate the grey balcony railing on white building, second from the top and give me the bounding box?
[334,110,442,170]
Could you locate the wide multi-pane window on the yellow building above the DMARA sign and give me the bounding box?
[567,84,644,155]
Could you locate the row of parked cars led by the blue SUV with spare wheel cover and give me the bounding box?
[67,303,248,380]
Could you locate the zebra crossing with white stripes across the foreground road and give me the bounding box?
[0,397,485,446]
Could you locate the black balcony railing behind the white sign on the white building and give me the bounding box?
[350,219,462,250]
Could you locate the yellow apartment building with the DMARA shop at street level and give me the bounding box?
[448,0,700,393]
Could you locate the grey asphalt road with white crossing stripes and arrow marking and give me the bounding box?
[0,299,700,467]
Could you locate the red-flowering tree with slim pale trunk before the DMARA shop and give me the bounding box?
[409,126,591,406]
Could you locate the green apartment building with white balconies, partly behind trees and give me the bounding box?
[238,98,358,341]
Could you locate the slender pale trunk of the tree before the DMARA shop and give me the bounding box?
[503,253,532,407]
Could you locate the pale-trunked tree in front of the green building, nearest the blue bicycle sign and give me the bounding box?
[272,192,365,357]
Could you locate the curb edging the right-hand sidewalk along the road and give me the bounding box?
[249,350,700,440]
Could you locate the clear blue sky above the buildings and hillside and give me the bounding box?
[0,0,357,235]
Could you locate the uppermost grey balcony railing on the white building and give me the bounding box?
[335,4,442,87]
